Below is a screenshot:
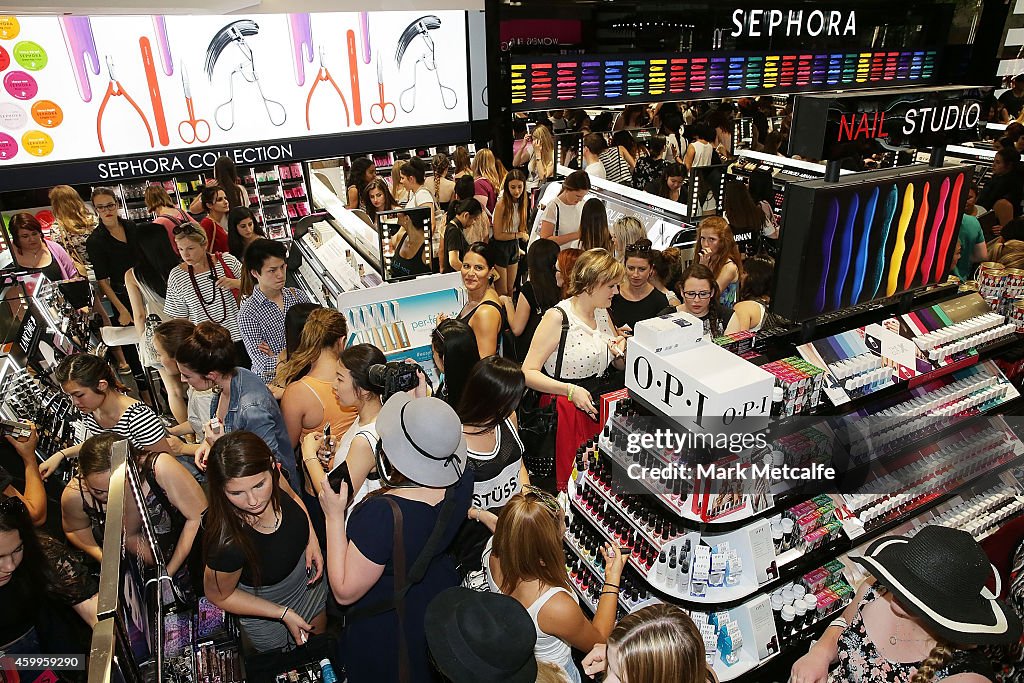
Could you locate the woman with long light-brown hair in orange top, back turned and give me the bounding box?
[274,308,357,497]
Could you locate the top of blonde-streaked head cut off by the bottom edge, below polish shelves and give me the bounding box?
[583,603,718,683]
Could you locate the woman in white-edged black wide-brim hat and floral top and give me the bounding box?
[790,525,1021,683]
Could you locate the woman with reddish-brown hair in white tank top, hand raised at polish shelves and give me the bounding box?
[481,486,626,683]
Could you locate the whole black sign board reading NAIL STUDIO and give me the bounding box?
[790,85,992,159]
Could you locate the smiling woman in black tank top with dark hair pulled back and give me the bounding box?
[459,242,513,358]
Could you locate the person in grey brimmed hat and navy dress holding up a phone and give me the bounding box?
[321,393,473,683]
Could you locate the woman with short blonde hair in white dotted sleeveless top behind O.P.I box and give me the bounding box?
[522,249,626,488]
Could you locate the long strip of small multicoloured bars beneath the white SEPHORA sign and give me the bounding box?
[512,50,937,112]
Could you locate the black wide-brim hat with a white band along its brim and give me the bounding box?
[852,524,1021,645]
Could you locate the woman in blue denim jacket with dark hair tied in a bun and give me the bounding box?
[177,322,301,483]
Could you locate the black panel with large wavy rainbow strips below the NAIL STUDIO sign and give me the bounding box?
[772,167,971,321]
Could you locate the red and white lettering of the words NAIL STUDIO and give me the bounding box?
[836,101,981,142]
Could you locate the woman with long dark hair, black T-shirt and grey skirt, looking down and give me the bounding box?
[203,431,327,652]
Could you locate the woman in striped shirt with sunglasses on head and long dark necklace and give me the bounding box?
[164,223,252,368]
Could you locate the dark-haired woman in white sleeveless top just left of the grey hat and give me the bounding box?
[302,344,387,510]
